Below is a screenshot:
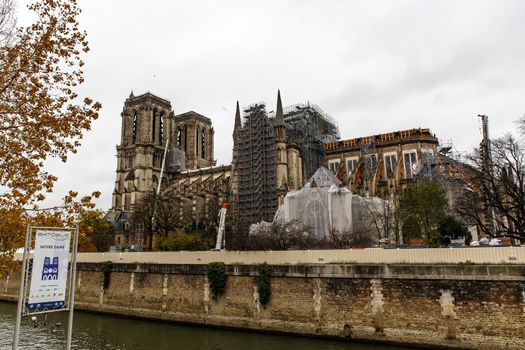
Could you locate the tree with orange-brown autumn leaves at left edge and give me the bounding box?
[0,0,101,270]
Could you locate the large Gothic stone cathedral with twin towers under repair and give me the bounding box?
[108,92,438,249]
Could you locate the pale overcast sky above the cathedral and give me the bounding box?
[19,0,525,209]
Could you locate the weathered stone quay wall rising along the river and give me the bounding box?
[0,262,525,350]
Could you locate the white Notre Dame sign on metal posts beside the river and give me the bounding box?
[13,225,78,350]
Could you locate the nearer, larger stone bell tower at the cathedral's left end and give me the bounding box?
[111,92,176,211]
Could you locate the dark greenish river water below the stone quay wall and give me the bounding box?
[0,302,418,350]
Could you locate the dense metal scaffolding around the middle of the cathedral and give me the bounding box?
[232,98,339,232]
